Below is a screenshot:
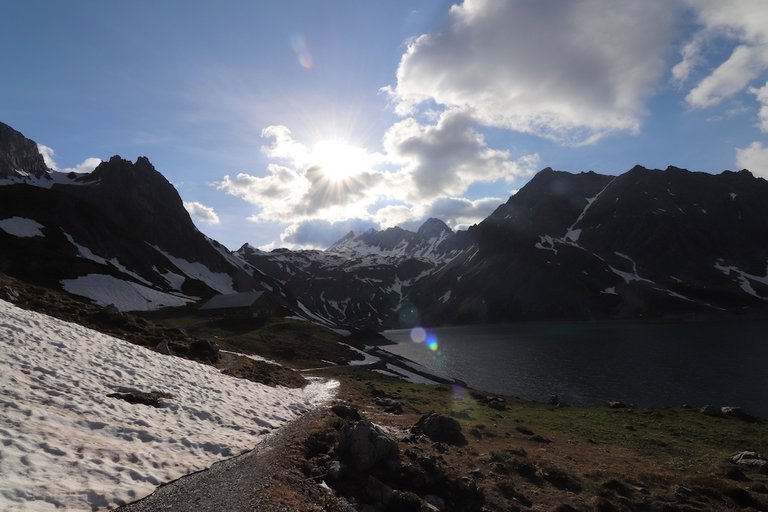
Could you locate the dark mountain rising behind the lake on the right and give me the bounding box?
[410,166,768,324]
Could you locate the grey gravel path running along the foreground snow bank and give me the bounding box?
[116,407,326,512]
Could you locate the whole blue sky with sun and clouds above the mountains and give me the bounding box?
[0,0,768,250]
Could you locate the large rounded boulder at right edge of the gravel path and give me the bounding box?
[338,420,400,471]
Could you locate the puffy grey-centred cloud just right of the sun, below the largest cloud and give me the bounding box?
[384,111,539,201]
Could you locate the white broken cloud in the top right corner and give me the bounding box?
[672,0,768,108]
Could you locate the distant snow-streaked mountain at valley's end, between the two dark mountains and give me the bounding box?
[236,219,467,329]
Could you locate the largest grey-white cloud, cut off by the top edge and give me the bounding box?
[385,0,675,144]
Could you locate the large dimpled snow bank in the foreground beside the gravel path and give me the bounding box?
[0,301,338,512]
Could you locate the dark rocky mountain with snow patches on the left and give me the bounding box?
[0,125,284,310]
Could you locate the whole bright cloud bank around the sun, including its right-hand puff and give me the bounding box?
[213,118,539,236]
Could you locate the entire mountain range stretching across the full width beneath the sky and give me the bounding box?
[0,120,768,329]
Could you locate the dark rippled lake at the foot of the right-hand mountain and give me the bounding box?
[382,321,768,417]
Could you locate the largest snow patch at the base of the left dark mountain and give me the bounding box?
[61,274,199,311]
